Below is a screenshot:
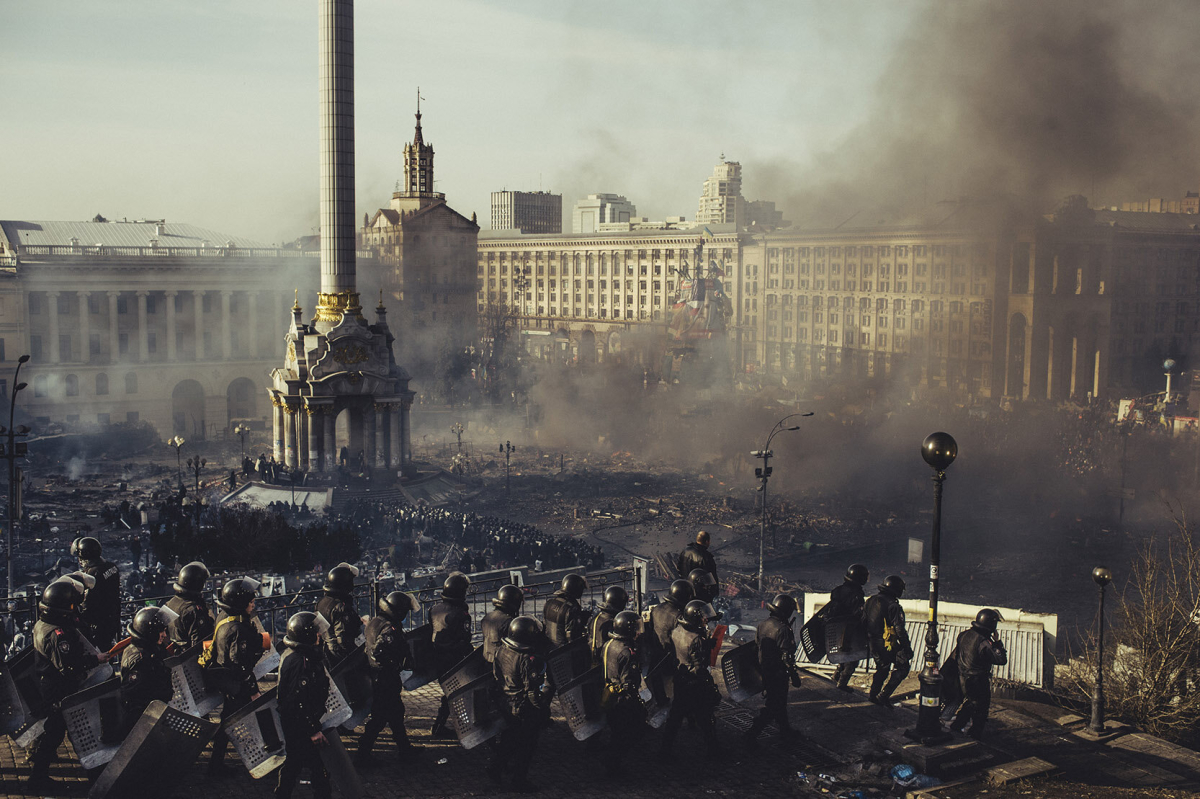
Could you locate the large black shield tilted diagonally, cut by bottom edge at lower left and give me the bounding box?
[88,699,220,799]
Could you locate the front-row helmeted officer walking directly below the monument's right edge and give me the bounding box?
[355,591,419,765]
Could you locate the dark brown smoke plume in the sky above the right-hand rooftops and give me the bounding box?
[748,0,1200,226]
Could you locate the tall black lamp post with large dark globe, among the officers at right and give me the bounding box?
[910,433,959,744]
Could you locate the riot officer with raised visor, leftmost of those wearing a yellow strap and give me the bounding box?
[200,577,263,776]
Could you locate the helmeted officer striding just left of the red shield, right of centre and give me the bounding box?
[662,600,720,758]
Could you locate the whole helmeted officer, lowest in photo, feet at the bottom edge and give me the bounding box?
[275,611,332,799]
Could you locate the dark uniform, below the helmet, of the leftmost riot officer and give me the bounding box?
[29,619,100,780]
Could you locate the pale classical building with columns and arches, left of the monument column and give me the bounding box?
[0,217,317,438]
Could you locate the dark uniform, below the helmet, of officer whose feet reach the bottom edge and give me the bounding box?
[275,649,332,799]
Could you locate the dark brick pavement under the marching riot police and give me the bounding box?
[0,675,1200,799]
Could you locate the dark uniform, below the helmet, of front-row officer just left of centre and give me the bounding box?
[492,644,552,786]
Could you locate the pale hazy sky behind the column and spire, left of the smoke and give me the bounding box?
[0,0,914,242]
